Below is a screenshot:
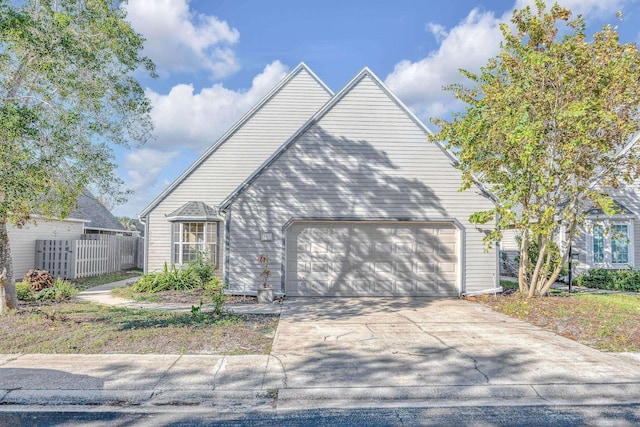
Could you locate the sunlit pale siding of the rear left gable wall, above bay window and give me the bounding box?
[146,69,330,271]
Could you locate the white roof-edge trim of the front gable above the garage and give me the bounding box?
[220,67,495,209]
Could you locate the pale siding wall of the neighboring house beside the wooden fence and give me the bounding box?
[8,220,83,281]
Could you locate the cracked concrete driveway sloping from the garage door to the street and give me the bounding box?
[272,298,640,409]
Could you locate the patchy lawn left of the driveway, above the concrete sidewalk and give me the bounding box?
[0,302,278,354]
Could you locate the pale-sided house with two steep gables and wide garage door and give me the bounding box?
[140,64,499,296]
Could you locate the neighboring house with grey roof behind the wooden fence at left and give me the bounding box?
[8,194,131,280]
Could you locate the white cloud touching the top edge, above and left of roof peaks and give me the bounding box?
[124,0,240,78]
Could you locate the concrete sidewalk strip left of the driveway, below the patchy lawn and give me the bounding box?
[0,354,284,412]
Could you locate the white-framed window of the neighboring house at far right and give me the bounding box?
[588,220,633,268]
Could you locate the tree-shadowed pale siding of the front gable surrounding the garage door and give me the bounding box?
[228,75,496,292]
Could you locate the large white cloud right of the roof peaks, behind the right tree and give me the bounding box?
[385,0,630,119]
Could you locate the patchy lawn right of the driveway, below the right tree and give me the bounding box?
[469,293,640,352]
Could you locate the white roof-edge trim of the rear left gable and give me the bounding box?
[138,62,333,218]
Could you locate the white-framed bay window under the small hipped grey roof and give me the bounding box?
[173,222,218,265]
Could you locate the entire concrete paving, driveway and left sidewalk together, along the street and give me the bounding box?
[0,298,640,413]
